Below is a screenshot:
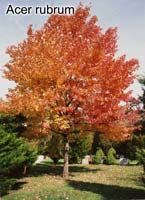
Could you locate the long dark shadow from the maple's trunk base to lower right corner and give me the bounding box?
[68,180,145,200]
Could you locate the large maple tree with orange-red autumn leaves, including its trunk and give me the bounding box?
[1,5,138,178]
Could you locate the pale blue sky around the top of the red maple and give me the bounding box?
[0,0,145,97]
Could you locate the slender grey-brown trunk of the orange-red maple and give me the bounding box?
[63,135,69,179]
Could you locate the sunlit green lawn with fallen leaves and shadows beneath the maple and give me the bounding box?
[2,162,145,200]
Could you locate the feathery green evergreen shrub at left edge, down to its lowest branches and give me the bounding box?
[0,125,37,195]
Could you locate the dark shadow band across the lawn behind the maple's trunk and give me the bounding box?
[27,163,100,176]
